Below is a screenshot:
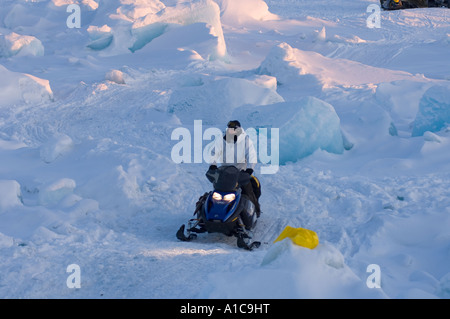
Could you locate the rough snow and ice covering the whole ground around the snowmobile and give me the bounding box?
[0,0,450,302]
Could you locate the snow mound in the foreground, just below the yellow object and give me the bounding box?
[201,239,386,299]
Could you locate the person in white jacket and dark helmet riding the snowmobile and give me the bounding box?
[206,120,261,217]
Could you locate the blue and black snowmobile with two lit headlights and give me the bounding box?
[176,166,261,250]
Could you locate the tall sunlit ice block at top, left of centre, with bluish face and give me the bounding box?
[87,0,227,59]
